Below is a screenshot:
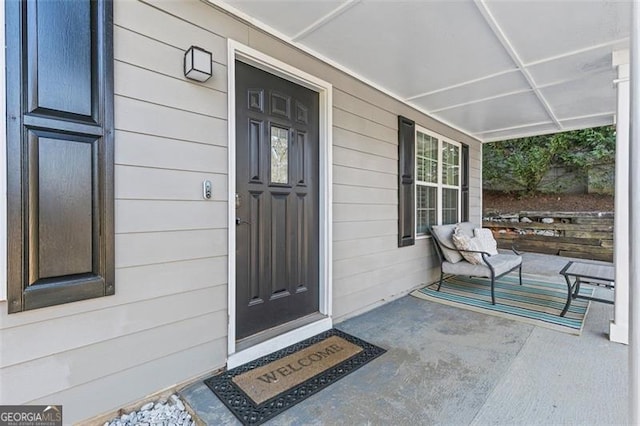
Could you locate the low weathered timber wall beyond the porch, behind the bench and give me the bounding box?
[482,211,613,262]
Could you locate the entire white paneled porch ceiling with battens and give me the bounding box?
[210,0,631,142]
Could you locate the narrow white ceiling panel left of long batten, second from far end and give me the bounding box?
[410,71,531,112]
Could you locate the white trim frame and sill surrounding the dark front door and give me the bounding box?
[227,39,333,368]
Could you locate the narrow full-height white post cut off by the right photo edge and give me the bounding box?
[628,0,640,425]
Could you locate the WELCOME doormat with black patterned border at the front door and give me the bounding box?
[204,328,386,425]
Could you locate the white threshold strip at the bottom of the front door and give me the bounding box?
[227,312,333,370]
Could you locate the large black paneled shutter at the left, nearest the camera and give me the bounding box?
[6,0,115,313]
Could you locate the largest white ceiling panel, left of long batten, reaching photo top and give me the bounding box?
[299,0,515,97]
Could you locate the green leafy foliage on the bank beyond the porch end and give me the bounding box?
[483,126,616,195]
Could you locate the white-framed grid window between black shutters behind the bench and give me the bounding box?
[415,127,462,236]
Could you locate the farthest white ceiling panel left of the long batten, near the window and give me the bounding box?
[433,93,549,133]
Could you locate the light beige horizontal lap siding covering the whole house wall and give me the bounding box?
[0,0,481,422]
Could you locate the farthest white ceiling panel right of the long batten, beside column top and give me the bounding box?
[541,70,616,120]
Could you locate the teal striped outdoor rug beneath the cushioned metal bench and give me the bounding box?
[411,274,593,335]
